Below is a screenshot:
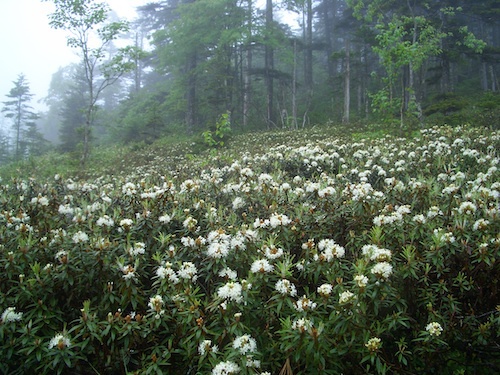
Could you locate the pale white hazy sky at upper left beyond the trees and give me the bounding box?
[0,0,152,117]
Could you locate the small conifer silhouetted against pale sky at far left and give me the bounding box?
[2,74,38,161]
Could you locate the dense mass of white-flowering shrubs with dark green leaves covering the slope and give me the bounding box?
[0,127,500,374]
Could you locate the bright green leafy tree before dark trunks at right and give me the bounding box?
[347,0,484,125]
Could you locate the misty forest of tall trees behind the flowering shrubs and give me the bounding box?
[0,0,500,164]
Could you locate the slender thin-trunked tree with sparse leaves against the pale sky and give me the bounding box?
[42,0,137,166]
